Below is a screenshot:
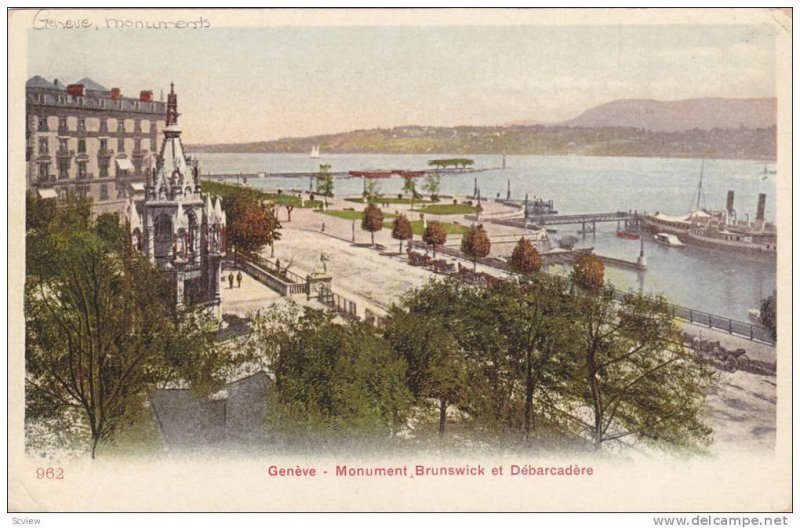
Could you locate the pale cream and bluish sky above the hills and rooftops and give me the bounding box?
[28,18,776,144]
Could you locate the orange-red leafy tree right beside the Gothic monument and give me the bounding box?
[228,201,281,253]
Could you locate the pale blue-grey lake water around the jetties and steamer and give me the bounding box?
[191,153,776,321]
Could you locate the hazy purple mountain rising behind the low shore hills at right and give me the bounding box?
[559,98,777,132]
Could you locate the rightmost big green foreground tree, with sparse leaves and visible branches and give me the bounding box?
[570,290,713,449]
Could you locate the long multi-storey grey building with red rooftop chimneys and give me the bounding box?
[25,76,166,213]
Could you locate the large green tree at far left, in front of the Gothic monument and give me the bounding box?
[25,200,224,458]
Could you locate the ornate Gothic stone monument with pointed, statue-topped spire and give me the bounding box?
[128,84,226,318]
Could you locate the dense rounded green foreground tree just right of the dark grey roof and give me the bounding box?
[256,308,411,436]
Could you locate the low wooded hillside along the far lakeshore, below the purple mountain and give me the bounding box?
[187,125,776,159]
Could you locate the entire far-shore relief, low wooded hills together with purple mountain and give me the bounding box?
[187,98,777,159]
